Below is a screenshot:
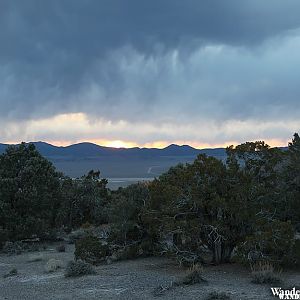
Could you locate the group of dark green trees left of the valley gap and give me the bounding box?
[0,143,109,241]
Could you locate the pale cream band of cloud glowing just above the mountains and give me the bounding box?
[0,113,300,148]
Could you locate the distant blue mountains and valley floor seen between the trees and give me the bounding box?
[0,142,226,188]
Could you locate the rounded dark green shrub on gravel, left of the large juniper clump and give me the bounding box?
[74,236,109,264]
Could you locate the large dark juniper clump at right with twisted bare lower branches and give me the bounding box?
[141,134,300,264]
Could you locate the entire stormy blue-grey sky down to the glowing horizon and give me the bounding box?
[0,0,300,148]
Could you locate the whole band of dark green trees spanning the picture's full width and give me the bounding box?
[0,134,300,264]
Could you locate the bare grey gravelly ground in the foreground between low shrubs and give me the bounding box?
[0,245,300,300]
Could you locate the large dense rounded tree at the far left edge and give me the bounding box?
[0,143,60,240]
